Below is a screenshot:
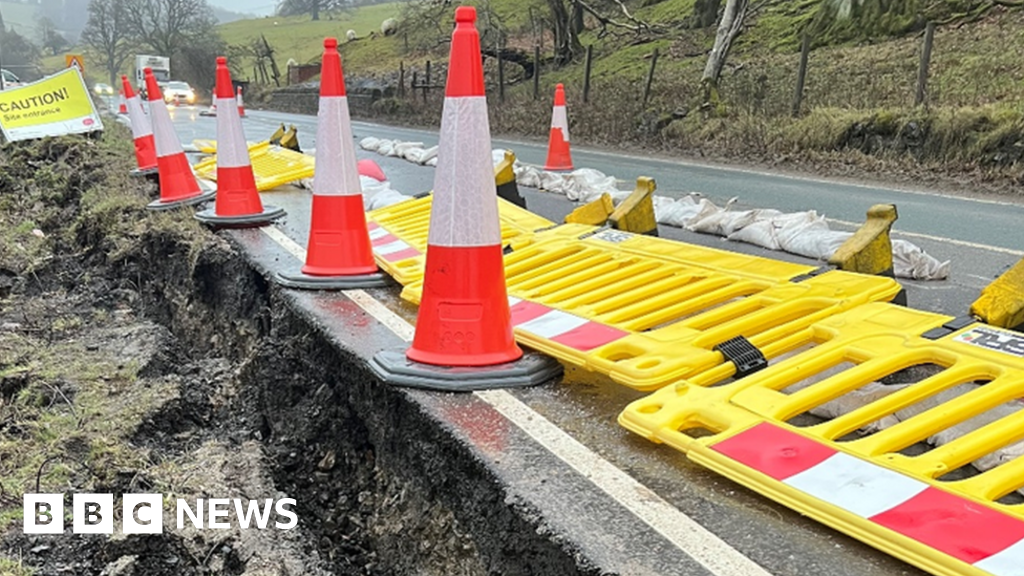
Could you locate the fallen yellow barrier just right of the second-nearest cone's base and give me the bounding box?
[367,195,554,285]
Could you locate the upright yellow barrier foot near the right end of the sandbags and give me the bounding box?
[828,204,899,278]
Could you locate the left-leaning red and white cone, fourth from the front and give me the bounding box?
[142,68,214,210]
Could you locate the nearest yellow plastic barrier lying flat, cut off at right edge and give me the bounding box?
[620,303,1024,576]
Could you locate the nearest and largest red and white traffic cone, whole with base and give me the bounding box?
[368,6,561,389]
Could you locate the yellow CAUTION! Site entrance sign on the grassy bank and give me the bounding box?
[0,68,103,141]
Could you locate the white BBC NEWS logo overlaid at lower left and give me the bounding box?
[24,494,299,534]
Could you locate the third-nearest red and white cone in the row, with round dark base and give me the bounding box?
[196,56,285,228]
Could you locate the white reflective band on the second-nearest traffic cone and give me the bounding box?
[313,96,362,196]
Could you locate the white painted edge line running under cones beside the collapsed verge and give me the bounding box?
[260,227,770,576]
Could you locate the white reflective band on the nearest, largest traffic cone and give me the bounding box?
[425,96,502,246]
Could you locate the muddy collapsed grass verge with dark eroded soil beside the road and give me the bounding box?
[0,125,540,576]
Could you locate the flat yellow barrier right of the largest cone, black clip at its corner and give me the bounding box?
[402,224,901,389]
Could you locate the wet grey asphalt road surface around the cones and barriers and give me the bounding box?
[161,109,1024,576]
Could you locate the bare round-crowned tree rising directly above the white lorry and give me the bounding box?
[125,0,217,56]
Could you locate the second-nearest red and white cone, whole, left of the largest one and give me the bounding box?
[274,38,385,289]
